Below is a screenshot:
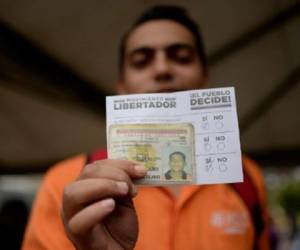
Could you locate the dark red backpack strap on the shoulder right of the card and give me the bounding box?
[230,165,265,250]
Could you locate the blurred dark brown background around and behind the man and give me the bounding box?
[0,0,300,250]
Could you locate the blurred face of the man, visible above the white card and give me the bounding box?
[118,20,206,94]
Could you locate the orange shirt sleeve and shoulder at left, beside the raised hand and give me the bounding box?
[22,154,86,249]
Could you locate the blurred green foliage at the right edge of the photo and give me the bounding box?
[278,181,300,214]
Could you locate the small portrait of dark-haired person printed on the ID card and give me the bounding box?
[165,151,191,180]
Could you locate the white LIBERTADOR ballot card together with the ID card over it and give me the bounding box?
[106,87,243,185]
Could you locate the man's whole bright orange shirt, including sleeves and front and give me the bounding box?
[22,155,269,250]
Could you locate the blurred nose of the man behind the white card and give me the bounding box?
[154,51,173,83]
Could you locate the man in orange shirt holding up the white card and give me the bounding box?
[23,6,268,250]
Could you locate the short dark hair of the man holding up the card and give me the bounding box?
[119,5,207,73]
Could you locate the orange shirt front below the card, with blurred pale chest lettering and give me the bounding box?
[136,185,253,249]
